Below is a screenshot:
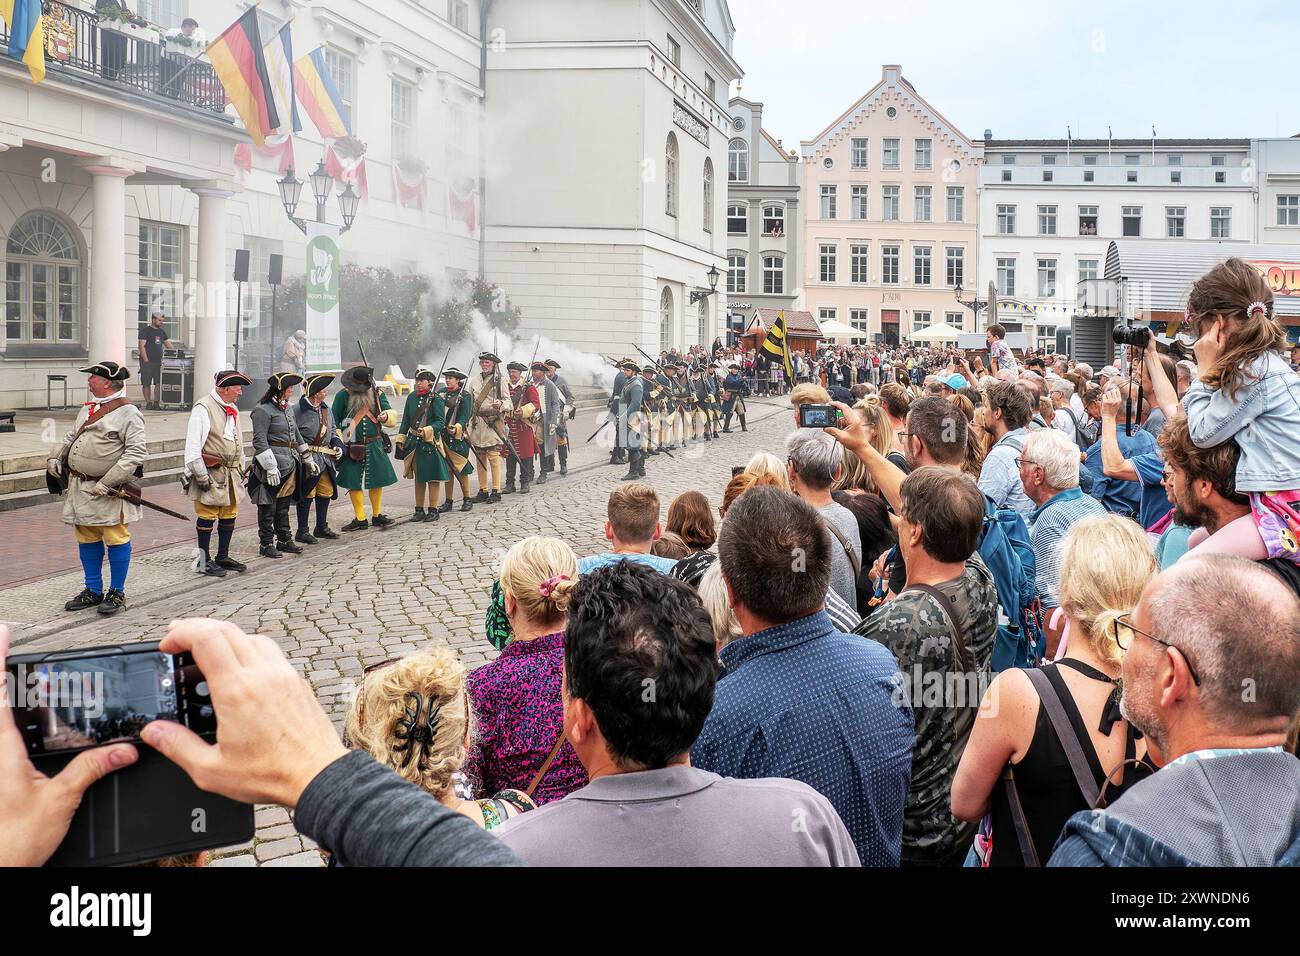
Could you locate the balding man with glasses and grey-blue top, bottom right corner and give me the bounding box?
[1049,554,1300,866]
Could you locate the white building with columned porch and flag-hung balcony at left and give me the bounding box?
[0,0,482,408]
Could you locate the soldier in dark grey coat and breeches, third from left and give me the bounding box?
[248,372,320,558]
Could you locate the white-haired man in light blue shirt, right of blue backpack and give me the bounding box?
[1017,428,1106,656]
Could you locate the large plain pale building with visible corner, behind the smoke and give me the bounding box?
[482,0,741,355]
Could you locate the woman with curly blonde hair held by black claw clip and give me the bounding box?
[343,648,537,830]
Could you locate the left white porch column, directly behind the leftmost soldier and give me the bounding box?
[82,156,138,365]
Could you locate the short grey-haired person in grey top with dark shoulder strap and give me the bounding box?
[785,428,862,610]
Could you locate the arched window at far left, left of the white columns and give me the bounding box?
[4,212,82,345]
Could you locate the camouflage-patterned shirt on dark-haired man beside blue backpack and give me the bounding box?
[857,554,997,864]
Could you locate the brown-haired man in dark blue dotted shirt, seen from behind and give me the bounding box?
[690,488,915,866]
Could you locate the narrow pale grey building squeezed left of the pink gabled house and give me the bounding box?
[725,96,803,329]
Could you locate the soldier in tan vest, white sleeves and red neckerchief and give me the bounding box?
[181,369,252,578]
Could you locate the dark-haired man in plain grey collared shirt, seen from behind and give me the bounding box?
[494,562,858,866]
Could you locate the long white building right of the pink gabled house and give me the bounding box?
[979,134,1253,350]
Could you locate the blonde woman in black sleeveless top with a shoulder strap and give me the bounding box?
[952,515,1156,866]
